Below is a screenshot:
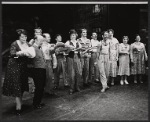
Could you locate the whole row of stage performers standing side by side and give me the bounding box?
[3,28,148,115]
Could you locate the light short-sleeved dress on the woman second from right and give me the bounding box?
[118,43,130,76]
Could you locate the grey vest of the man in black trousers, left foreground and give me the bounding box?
[33,45,46,69]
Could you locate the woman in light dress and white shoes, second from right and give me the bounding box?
[118,36,130,85]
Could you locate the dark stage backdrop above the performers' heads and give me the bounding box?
[2,4,148,67]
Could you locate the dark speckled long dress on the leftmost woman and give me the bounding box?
[3,41,29,97]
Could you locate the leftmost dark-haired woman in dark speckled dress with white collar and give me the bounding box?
[3,29,29,115]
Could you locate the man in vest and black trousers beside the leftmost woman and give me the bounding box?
[33,35,46,108]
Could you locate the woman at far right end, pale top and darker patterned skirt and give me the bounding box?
[131,35,148,83]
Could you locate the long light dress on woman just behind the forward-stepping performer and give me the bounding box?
[109,38,119,77]
